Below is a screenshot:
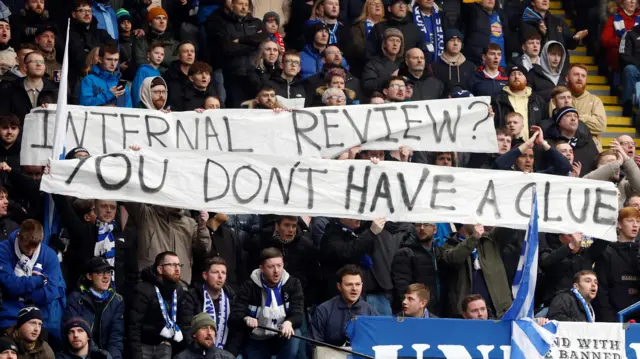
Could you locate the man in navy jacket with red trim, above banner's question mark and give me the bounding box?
[466,43,509,99]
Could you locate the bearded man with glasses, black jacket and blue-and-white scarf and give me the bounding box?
[128,251,183,359]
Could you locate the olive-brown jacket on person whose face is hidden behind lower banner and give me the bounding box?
[125,202,211,286]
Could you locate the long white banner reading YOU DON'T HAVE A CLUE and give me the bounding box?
[41,149,618,241]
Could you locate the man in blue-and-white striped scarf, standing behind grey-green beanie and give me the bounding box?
[178,258,235,348]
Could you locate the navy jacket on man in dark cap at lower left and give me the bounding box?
[62,281,124,359]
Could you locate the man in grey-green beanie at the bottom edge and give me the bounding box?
[174,313,235,359]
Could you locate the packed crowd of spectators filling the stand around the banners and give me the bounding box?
[0,0,640,359]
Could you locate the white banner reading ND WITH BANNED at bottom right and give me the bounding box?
[545,322,627,359]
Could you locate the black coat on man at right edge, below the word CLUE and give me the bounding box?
[593,242,640,322]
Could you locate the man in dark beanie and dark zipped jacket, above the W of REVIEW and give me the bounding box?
[431,29,476,89]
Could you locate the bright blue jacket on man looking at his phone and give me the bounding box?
[80,65,133,108]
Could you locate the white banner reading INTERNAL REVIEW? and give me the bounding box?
[20,97,498,165]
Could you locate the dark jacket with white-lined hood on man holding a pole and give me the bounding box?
[225,269,304,355]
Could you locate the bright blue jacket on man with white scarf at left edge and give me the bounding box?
[0,231,66,339]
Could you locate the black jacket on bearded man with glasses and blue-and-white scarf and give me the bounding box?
[127,265,184,359]
